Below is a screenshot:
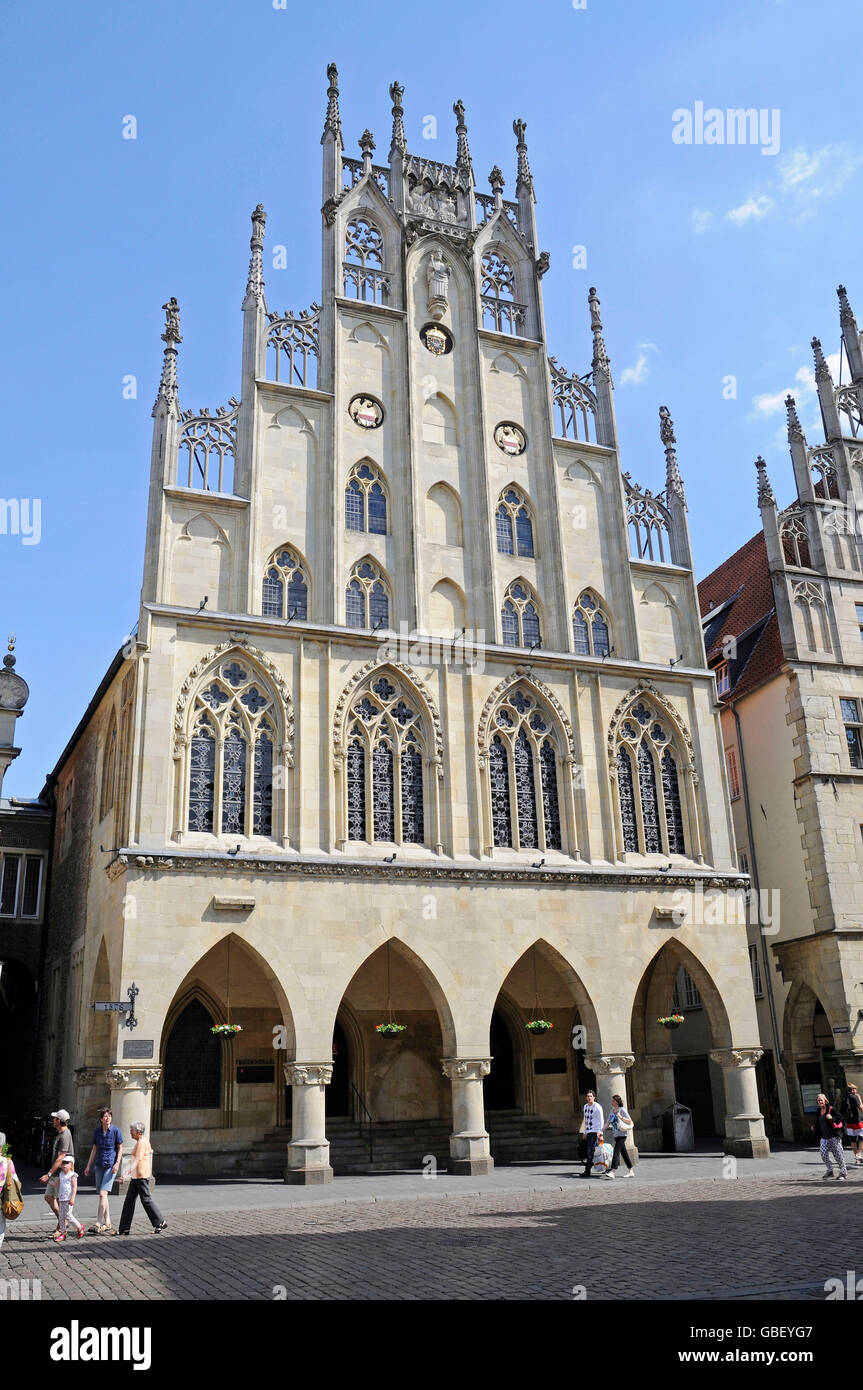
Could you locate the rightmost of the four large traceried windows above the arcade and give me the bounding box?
[614,699,687,855]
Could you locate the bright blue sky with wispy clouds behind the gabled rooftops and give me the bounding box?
[0,0,863,795]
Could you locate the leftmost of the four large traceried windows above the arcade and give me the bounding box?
[186,653,277,838]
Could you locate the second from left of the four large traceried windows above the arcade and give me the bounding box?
[340,673,427,845]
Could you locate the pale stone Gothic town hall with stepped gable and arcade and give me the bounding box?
[39,67,767,1183]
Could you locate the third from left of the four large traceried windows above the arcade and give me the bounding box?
[488,685,563,851]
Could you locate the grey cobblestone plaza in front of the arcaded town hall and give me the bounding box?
[0,1150,863,1301]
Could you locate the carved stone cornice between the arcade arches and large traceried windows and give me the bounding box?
[106,849,749,892]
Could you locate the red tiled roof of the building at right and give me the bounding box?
[698,531,784,701]
